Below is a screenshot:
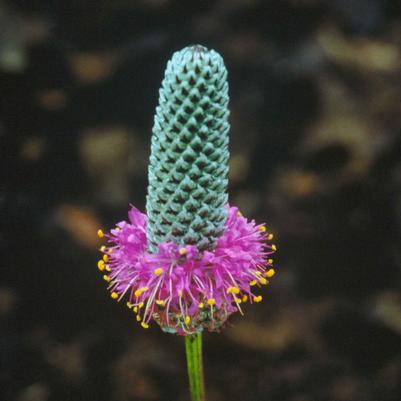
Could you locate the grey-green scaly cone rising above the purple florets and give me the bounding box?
[146,45,229,252]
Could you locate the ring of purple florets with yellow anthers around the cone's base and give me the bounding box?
[98,206,276,335]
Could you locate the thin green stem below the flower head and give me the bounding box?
[185,333,206,401]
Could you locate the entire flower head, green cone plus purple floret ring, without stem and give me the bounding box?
[98,46,276,335]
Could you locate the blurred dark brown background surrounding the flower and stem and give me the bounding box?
[0,0,401,401]
